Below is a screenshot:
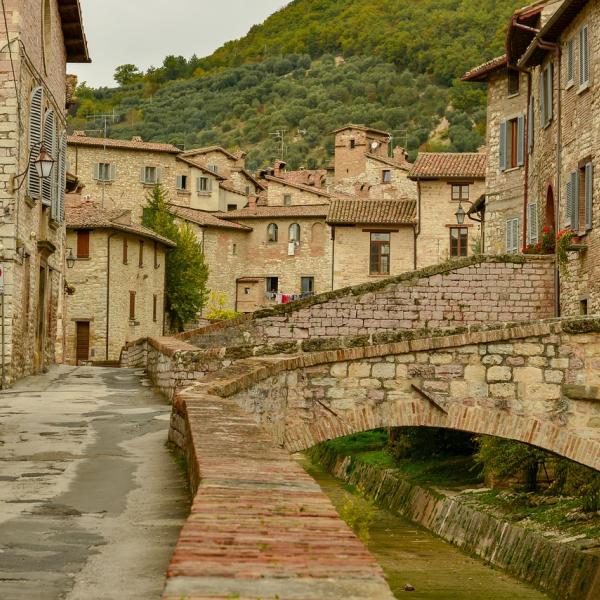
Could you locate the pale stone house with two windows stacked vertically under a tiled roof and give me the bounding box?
[408,152,487,268]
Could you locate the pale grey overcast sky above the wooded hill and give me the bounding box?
[68,0,289,86]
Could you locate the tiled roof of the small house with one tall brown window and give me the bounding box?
[327,200,417,225]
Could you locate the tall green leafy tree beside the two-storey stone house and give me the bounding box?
[143,184,210,331]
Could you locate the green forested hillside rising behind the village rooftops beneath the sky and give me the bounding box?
[71,0,520,168]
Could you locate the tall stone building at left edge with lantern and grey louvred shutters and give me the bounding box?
[0,0,89,387]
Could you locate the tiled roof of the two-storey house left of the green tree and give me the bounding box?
[65,199,176,248]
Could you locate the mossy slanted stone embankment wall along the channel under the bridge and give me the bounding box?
[310,447,600,600]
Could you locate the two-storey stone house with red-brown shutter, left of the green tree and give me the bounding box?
[65,195,175,364]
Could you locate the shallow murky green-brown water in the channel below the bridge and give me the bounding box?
[302,459,548,600]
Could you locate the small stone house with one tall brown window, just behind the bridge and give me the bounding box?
[327,199,417,289]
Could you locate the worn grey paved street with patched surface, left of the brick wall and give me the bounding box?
[0,366,188,600]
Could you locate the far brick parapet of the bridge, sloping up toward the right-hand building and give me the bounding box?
[182,255,554,349]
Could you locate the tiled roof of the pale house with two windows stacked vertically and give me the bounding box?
[408,152,487,179]
